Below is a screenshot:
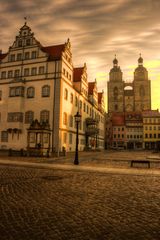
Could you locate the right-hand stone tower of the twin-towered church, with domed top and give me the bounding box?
[133,54,151,111]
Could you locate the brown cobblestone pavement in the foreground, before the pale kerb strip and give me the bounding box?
[0,165,160,240]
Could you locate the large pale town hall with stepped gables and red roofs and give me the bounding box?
[0,23,104,154]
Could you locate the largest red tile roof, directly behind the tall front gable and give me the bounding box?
[41,44,65,60]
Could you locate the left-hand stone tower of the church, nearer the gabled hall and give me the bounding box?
[107,56,124,113]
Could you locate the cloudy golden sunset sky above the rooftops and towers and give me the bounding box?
[0,0,160,109]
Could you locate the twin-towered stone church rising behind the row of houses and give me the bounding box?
[108,55,151,114]
